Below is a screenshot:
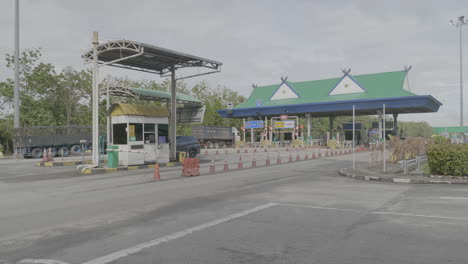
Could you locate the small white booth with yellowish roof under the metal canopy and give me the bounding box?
[108,104,169,166]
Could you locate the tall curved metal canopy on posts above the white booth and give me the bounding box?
[82,32,222,164]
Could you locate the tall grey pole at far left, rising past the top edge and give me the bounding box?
[13,0,20,156]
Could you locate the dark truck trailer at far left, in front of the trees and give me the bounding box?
[13,126,92,158]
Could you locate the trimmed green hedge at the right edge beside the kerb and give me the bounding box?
[427,143,468,176]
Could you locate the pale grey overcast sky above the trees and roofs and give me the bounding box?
[0,0,468,126]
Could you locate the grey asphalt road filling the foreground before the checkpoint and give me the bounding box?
[0,154,468,264]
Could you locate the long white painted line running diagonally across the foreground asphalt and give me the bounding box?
[82,203,277,264]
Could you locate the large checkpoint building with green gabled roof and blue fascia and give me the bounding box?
[218,68,442,143]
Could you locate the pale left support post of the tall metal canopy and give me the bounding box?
[92,31,99,164]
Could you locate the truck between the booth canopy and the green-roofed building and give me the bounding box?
[192,126,240,148]
